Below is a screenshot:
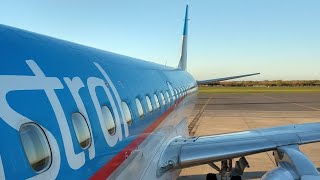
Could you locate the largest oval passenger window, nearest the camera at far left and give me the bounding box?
[19,123,52,173]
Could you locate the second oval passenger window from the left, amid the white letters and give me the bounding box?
[72,113,91,149]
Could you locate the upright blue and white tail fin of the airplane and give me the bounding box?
[178,5,189,71]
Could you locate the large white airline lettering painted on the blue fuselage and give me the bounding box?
[0,60,129,177]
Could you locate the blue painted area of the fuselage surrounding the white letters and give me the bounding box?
[0,25,196,179]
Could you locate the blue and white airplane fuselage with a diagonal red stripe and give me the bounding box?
[0,25,197,179]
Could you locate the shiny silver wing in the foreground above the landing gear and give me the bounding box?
[159,123,320,178]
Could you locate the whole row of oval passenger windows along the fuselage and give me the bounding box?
[19,82,188,173]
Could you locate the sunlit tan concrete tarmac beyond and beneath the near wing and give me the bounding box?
[179,93,320,180]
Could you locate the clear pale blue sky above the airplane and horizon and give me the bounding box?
[0,0,320,80]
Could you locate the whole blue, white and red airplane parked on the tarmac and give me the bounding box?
[0,3,320,180]
